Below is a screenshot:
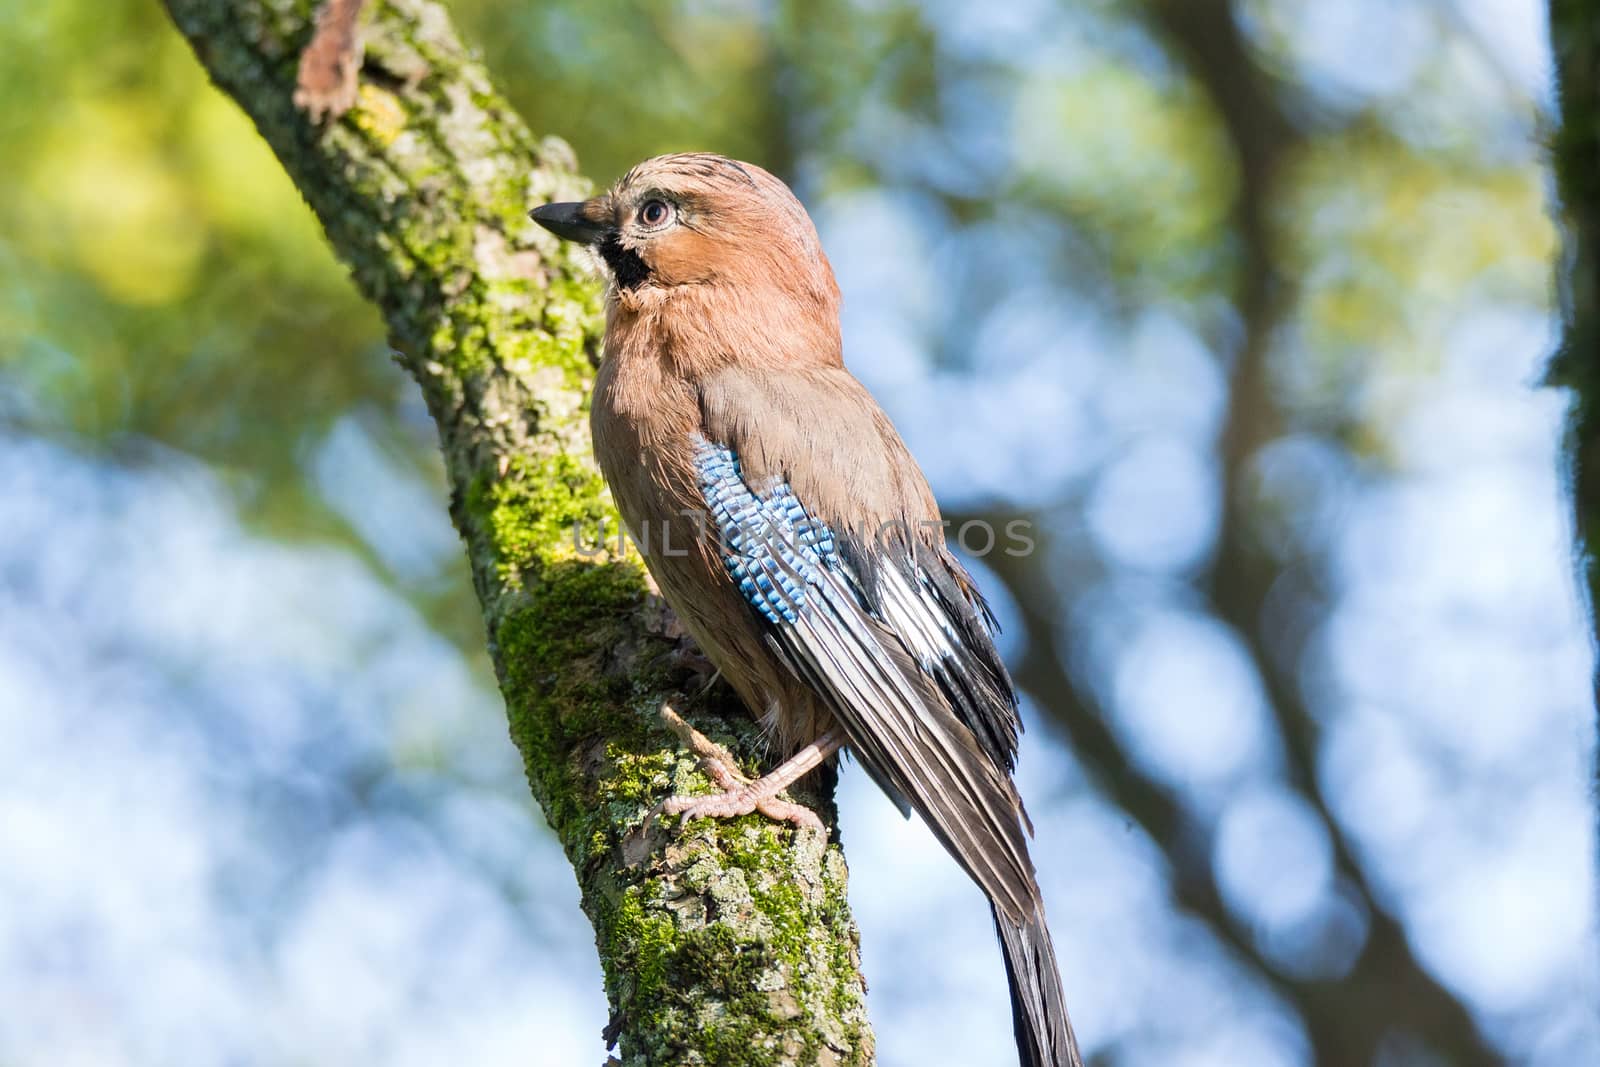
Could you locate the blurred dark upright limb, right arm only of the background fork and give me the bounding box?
[1150,0,1499,1064]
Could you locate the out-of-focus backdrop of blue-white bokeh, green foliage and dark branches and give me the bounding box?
[0,0,1597,1065]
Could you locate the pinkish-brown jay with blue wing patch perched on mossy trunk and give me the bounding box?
[530,152,1082,1067]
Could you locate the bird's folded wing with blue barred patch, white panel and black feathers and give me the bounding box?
[694,437,1038,918]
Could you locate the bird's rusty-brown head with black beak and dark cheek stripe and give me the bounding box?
[531,152,838,317]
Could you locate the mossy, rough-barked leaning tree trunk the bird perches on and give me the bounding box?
[166,0,874,1067]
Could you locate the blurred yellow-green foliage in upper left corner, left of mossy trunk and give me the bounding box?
[0,3,380,483]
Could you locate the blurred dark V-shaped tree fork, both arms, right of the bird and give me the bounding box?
[952,0,1491,1067]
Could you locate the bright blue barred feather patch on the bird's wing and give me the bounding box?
[694,438,838,625]
